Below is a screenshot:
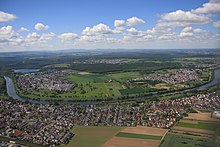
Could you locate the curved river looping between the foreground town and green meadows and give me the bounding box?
[4,68,220,105]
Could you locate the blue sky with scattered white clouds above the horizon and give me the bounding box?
[0,0,220,51]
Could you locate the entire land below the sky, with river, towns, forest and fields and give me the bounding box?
[0,50,220,147]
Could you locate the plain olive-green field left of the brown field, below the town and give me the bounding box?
[61,126,123,147]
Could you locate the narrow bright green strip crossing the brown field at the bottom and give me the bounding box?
[115,132,162,140]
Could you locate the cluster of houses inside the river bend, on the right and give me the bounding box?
[129,69,201,84]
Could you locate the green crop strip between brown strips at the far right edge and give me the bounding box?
[176,121,220,131]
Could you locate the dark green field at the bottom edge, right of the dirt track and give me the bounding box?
[160,133,212,147]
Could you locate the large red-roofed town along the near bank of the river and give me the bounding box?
[0,93,220,146]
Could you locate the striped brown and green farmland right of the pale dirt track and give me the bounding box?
[160,112,220,147]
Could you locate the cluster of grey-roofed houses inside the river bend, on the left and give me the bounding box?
[17,70,73,91]
